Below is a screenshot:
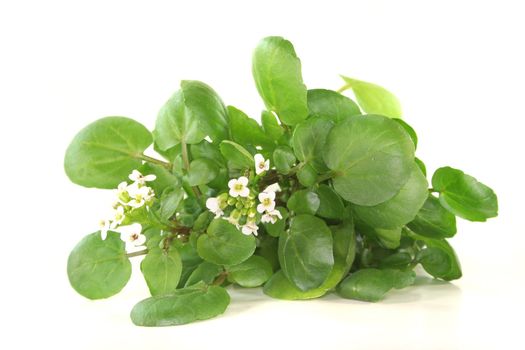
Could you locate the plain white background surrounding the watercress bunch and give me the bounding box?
[0,0,525,349]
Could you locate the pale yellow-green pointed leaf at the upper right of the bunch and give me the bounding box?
[341,76,403,118]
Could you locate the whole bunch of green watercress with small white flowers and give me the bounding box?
[65,37,497,326]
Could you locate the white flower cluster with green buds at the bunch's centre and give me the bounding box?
[206,154,282,235]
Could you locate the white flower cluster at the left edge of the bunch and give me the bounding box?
[100,170,157,249]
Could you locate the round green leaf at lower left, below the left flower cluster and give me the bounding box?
[67,231,131,299]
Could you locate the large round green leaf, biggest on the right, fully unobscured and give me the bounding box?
[324,115,414,206]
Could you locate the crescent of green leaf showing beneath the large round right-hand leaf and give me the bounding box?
[354,164,428,229]
